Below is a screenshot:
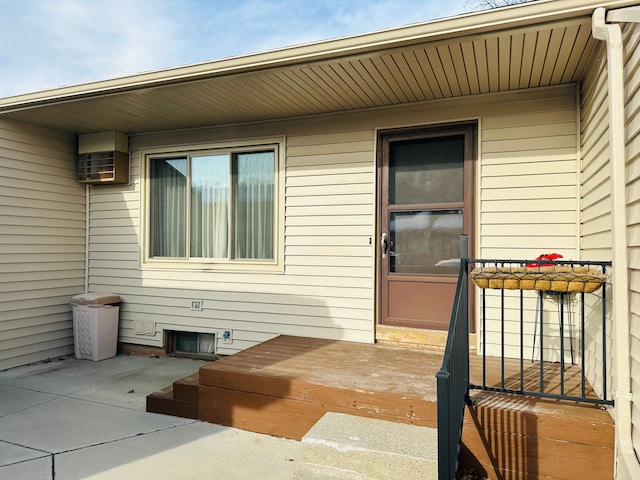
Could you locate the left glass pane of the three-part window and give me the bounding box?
[149,158,187,258]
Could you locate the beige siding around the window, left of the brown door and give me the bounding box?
[90,127,375,353]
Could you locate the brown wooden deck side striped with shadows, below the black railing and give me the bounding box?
[460,392,615,480]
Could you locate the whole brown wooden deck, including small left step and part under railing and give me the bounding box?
[147,336,613,480]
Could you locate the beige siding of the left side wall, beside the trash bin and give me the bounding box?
[0,120,85,369]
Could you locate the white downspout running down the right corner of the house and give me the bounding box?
[592,8,640,479]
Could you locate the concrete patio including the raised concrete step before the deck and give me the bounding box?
[0,355,437,480]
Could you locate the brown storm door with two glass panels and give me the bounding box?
[378,124,475,330]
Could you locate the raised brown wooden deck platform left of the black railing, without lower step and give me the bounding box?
[198,336,442,440]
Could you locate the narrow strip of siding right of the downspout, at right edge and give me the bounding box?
[624,25,640,468]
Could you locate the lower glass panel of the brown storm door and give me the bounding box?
[389,210,462,274]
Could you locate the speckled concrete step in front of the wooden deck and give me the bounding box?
[293,412,438,480]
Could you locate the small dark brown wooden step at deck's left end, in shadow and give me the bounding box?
[147,373,199,419]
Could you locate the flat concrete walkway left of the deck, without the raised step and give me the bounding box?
[0,355,302,480]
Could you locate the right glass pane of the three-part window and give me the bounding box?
[233,150,275,260]
